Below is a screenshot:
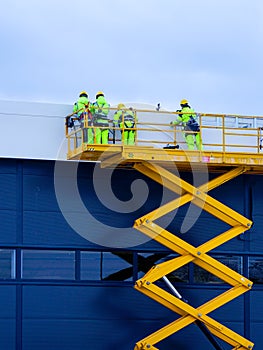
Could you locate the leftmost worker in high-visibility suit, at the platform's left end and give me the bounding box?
[73,91,94,143]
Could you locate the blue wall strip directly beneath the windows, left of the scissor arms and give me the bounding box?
[23,284,173,320]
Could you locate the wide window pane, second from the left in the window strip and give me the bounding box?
[22,250,75,280]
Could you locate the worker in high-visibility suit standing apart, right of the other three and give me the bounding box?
[171,99,202,150]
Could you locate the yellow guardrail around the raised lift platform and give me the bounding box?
[65,108,263,153]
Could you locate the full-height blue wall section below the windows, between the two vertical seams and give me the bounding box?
[23,286,248,350]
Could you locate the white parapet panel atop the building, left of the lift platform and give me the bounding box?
[0,101,72,160]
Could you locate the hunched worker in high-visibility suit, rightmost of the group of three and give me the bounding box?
[113,103,137,145]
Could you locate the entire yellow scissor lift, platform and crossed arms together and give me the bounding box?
[67,111,263,350]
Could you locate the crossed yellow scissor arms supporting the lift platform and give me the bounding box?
[134,163,254,350]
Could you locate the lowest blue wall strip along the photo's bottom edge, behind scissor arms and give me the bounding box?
[23,320,238,350]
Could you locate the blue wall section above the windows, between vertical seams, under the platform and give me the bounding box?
[21,157,250,251]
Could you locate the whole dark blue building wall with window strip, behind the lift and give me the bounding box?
[0,159,263,350]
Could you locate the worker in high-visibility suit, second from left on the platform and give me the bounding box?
[91,91,110,144]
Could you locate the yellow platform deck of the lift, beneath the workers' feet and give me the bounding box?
[67,144,263,174]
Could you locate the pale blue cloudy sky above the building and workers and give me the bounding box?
[0,0,263,115]
